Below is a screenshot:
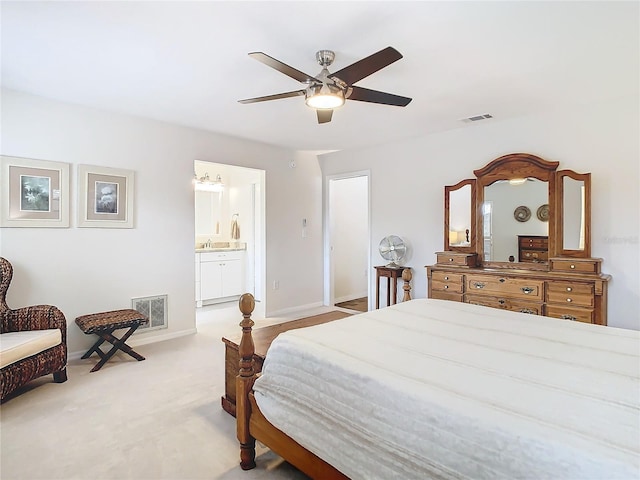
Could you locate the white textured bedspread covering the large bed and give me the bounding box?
[254,299,640,480]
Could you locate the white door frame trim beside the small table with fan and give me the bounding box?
[322,170,373,310]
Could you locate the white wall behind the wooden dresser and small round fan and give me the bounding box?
[320,98,640,329]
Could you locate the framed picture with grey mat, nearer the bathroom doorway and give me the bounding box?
[78,165,134,228]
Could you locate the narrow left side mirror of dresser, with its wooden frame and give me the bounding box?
[444,179,476,252]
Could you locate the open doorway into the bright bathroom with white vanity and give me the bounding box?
[194,160,266,317]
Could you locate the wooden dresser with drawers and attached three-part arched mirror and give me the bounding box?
[426,153,611,325]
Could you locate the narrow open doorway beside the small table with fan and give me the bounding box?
[324,171,372,311]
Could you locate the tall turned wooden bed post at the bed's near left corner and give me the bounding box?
[236,293,256,470]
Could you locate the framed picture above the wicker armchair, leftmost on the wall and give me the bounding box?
[0,156,69,228]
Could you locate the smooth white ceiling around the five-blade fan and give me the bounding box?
[1,1,640,150]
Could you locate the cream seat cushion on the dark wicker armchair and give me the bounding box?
[0,328,62,368]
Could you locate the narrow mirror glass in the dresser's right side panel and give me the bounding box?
[562,177,585,250]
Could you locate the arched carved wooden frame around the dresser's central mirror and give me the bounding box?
[473,153,560,270]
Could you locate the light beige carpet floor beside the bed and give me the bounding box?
[0,303,340,480]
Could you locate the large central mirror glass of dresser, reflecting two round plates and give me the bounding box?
[481,178,549,262]
